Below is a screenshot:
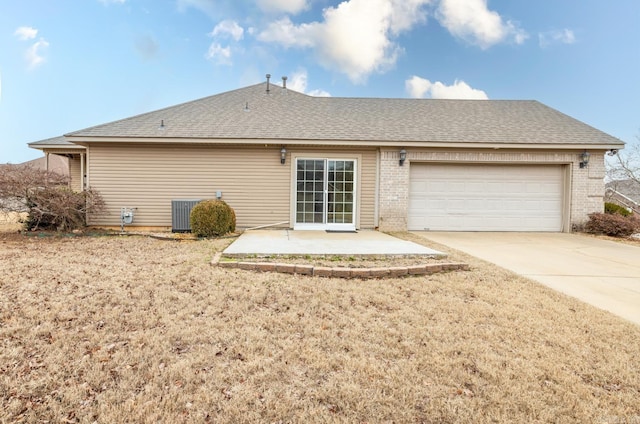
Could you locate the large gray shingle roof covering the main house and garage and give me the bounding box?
[67,83,623,145]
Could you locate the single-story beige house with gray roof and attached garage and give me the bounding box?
[29,78,624,232]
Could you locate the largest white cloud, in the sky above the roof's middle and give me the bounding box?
[258,0,431,83]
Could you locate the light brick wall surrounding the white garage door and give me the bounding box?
[379,148,605,231]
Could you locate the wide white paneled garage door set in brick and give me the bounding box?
[408,163,563,231]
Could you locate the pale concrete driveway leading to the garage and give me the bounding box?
[415,232,640,325]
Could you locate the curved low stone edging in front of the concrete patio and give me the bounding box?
[211,253,469,279]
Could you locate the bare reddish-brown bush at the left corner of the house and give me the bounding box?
[0,165,104,231]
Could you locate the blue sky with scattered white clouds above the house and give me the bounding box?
[0,0,640,163]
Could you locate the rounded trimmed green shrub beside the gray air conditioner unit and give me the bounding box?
[189,200,236,237]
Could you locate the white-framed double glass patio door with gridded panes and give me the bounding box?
[294,159,356,231]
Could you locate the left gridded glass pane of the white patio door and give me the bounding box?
[296,159,325,224]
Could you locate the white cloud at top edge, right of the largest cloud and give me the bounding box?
[437,0,529,49]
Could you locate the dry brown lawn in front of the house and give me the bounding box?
[0,230,640,423]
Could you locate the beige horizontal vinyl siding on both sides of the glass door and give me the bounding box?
[88,143,375,228]
